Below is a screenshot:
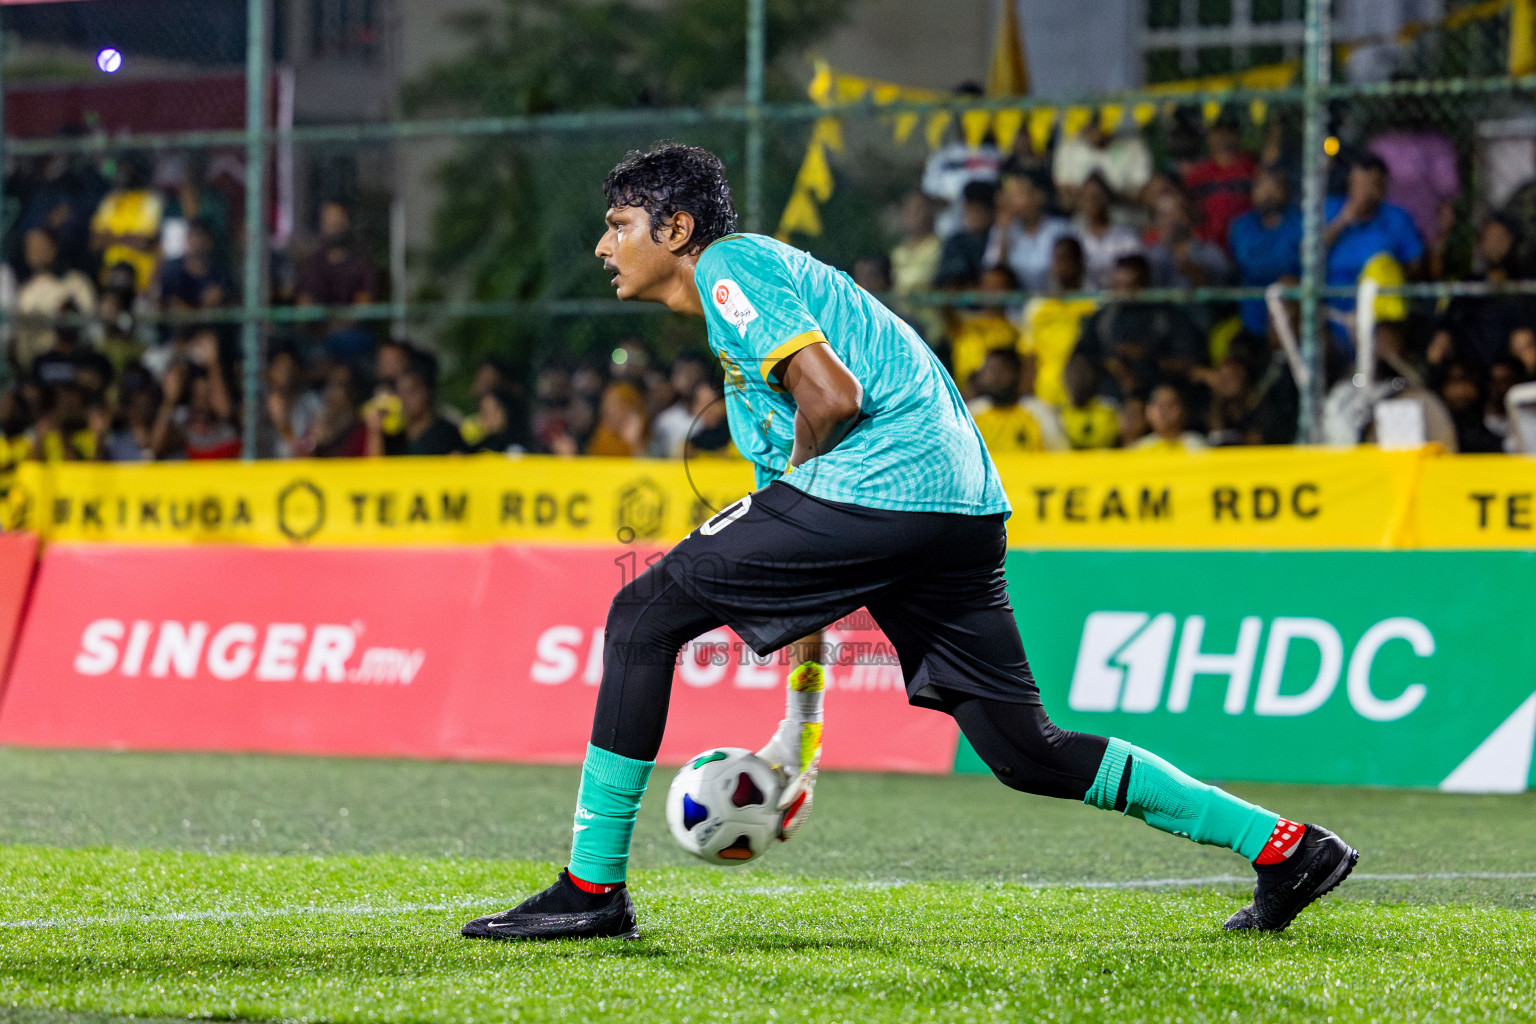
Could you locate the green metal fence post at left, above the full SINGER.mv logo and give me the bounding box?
[240,0,267,459]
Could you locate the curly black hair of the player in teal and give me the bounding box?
[602,143,736,253]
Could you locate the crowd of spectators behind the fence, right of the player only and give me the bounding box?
[890,105,1536,451]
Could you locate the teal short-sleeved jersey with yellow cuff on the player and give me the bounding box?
[694,235,1009,516]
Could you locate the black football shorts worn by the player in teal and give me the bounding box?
[656,482,1040,708]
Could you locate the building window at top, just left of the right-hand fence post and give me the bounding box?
[1138,0,1306,84]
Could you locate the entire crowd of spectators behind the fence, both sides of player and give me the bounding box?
[9,105,1536,482]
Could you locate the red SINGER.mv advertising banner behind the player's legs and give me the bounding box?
[0,543,957,772]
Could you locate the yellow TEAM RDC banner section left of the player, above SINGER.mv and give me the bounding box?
[5,456,753,547]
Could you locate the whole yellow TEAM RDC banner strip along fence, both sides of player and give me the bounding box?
[0,447,1536,550]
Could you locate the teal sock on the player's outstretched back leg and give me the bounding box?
[1083,738,1279,860]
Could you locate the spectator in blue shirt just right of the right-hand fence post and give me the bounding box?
[1322,154,1424,355]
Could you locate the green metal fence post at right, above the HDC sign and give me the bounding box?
[1298,0,1333,444]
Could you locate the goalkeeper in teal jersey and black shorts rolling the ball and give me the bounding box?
[464,144,1358,938]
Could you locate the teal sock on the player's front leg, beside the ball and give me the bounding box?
[568,743,656,886]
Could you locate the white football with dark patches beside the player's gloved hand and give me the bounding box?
[667,746,783,864]
